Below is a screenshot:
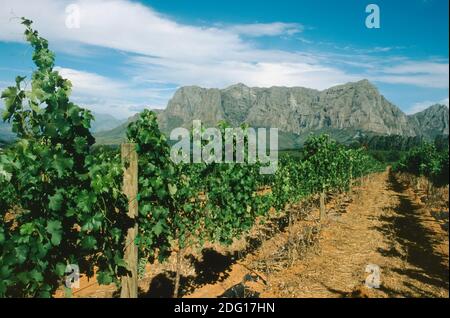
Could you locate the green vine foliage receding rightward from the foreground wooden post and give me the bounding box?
[127,111,380,268]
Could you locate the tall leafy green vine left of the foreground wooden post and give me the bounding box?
[0,19,126,297]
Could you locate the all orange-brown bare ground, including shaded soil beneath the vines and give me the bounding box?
[58,169,449,298]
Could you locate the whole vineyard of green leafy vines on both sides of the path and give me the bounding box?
[0,19,448,297]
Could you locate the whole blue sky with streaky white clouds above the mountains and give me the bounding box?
[0,0,449,118]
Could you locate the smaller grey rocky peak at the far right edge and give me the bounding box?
[408,104,449,139]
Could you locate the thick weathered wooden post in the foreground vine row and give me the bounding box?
[120,143,138,298]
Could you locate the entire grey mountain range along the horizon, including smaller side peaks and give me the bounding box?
[0,80,449,148]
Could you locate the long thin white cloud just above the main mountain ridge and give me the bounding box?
[129,56,360,89]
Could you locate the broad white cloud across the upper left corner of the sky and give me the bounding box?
[0,0,246,61]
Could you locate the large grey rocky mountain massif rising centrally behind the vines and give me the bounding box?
[159,80,417,136]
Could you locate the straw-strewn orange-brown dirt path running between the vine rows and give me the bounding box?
[187,170,449,298]
